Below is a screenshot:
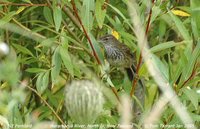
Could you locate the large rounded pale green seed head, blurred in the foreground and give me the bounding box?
[65,80,104,124]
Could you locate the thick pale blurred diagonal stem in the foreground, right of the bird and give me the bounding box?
[128,1,196,129]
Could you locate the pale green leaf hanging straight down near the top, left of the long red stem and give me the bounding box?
[53,6,62,31]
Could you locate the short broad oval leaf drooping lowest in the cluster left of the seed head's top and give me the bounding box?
[36,71,49,94]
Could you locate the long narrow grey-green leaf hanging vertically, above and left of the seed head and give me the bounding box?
[51,47,62,82]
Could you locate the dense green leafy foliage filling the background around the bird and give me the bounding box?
[0,0,200,128]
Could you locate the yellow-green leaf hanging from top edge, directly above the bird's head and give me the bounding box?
[95,0,106,28]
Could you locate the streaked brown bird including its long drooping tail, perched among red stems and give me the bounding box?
[99,34,145,120]
